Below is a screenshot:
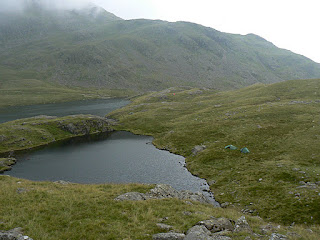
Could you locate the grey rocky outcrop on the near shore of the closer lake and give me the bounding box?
[115,184,213,204]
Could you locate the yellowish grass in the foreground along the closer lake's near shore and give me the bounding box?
[0,176,320,240]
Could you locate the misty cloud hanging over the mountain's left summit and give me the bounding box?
[0,0,90,12]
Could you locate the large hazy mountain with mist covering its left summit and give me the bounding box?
[0,0,320,91]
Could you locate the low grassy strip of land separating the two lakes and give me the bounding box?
[0,115,113,156]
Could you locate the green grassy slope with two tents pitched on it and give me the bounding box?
[109,80,320,225]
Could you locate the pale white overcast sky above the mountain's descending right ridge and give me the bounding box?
[90,0,320,63]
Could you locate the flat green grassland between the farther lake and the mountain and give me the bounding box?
[0,67,136,108]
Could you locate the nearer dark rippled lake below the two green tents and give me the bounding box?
[6,132,212,194]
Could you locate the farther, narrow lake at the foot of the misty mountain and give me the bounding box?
[0,99,129,123]
